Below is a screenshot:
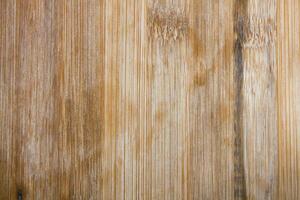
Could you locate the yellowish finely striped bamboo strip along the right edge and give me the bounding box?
[276,0,300,199]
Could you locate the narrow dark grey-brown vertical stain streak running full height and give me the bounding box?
[234,1,248,199]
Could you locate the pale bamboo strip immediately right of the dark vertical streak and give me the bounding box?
[235,0,278,199]
